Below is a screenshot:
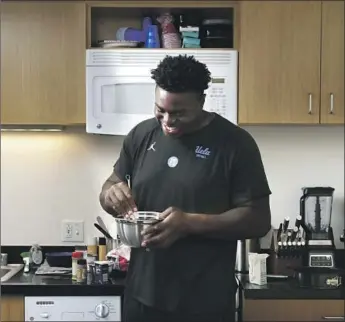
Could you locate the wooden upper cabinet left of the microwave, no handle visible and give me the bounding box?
[1,1,86,125]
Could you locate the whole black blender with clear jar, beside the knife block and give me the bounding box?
[300,187,335,268]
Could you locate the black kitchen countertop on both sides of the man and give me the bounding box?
[1,272,345,300]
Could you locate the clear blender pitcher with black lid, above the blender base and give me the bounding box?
[300,187,334,240]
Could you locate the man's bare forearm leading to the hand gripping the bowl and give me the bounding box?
[187,200,271,240]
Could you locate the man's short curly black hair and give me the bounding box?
[151,55,211,94]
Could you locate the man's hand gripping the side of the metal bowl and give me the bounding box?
[142,207,190,248]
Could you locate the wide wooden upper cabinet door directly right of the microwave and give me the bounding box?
[239,1,321,124]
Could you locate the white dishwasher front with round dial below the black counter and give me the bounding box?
[25,296,121,322]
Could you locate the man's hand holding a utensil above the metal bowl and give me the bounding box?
[104,182,138,216]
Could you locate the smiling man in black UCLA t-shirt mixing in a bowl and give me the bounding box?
[100,56,271,322]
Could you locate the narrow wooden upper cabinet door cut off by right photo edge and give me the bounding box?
[321,1,345,124]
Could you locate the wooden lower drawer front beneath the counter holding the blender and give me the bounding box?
[243,299,345,322]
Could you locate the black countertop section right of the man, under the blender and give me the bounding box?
[237,275,345,300]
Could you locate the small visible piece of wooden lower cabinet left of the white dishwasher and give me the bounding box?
[0,296,25,322]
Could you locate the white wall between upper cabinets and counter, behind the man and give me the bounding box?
[1,126,344,249]
